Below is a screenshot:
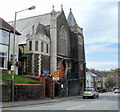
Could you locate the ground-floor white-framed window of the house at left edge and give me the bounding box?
[0,52,7,69]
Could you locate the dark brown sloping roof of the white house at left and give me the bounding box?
[0,18,21,35]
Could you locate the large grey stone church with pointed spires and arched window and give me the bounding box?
[11,7,86,96]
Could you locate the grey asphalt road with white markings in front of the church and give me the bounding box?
[1,92,118,110]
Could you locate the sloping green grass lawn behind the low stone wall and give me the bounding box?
[2,74,42,84]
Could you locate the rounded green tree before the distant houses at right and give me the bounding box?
[105,75,117,90]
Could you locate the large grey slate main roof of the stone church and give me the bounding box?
[9,11,60,44]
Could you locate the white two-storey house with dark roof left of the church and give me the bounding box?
[0,18,20,72]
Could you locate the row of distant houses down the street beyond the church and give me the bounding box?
[86,69,120,92]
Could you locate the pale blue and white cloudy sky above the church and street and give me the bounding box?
[0,0,118,70]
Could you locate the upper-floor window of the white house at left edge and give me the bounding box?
[0,30,9,45]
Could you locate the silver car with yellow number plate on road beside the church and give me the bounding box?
[83,88,99,99]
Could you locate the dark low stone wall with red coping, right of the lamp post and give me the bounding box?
[14,84,45,101]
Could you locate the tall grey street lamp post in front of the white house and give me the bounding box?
[11,6,36,101]
